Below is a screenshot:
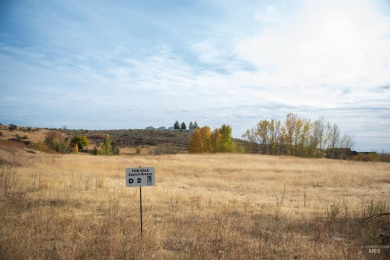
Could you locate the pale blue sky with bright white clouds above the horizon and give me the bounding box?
[0,0,390,152]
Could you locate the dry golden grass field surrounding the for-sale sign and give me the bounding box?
[0,147,390,259]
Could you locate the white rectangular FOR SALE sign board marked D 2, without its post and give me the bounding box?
[126,167,156,187]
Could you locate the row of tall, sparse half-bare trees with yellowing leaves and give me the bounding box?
[242,113,354,158]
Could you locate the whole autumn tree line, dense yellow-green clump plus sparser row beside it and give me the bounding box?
[188,113,354,158]
